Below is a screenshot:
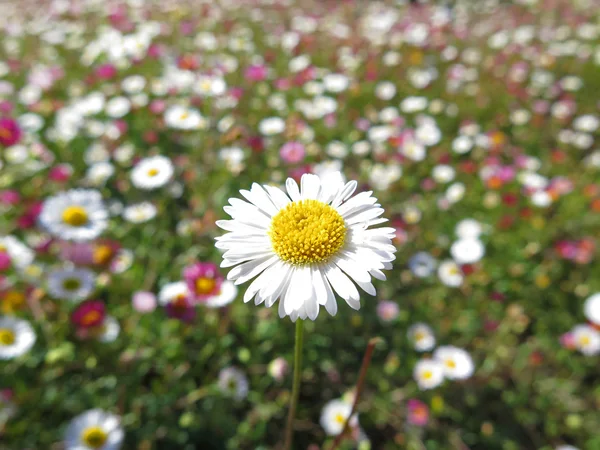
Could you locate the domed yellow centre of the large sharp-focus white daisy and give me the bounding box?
[269,200,347,265]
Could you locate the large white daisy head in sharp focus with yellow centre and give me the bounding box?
[216,174,396,321]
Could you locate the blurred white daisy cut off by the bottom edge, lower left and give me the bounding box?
[64,409,125,450]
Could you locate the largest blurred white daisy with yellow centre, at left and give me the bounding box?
[38,189,108,241]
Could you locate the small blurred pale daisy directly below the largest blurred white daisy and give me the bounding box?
[48,268,96,302]
